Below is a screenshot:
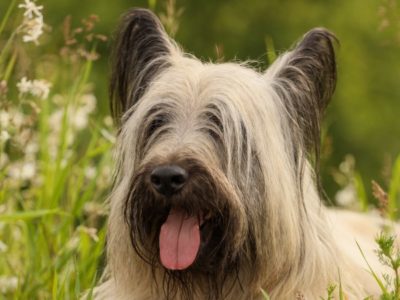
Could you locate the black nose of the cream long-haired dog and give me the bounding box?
[150,165,188,196]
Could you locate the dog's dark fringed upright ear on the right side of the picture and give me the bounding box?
[266,28,337,161]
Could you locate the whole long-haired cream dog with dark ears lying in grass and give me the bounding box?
[94,8,394,300]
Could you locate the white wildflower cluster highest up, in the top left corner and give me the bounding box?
[18,0,44,44]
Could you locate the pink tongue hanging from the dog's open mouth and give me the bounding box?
[160,208,200,270]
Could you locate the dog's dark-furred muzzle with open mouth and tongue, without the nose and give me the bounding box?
[124,159,242,281]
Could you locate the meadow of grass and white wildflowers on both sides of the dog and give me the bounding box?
[0,0,400,299]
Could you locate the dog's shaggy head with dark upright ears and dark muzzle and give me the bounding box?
[110,9,336,295]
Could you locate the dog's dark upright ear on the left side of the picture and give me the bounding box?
[110,8,177,125]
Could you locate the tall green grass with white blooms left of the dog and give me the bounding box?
[0,1,113,299]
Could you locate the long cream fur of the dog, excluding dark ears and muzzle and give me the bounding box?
[95,9,396,300]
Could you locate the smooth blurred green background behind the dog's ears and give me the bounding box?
[0,0,400,200]
